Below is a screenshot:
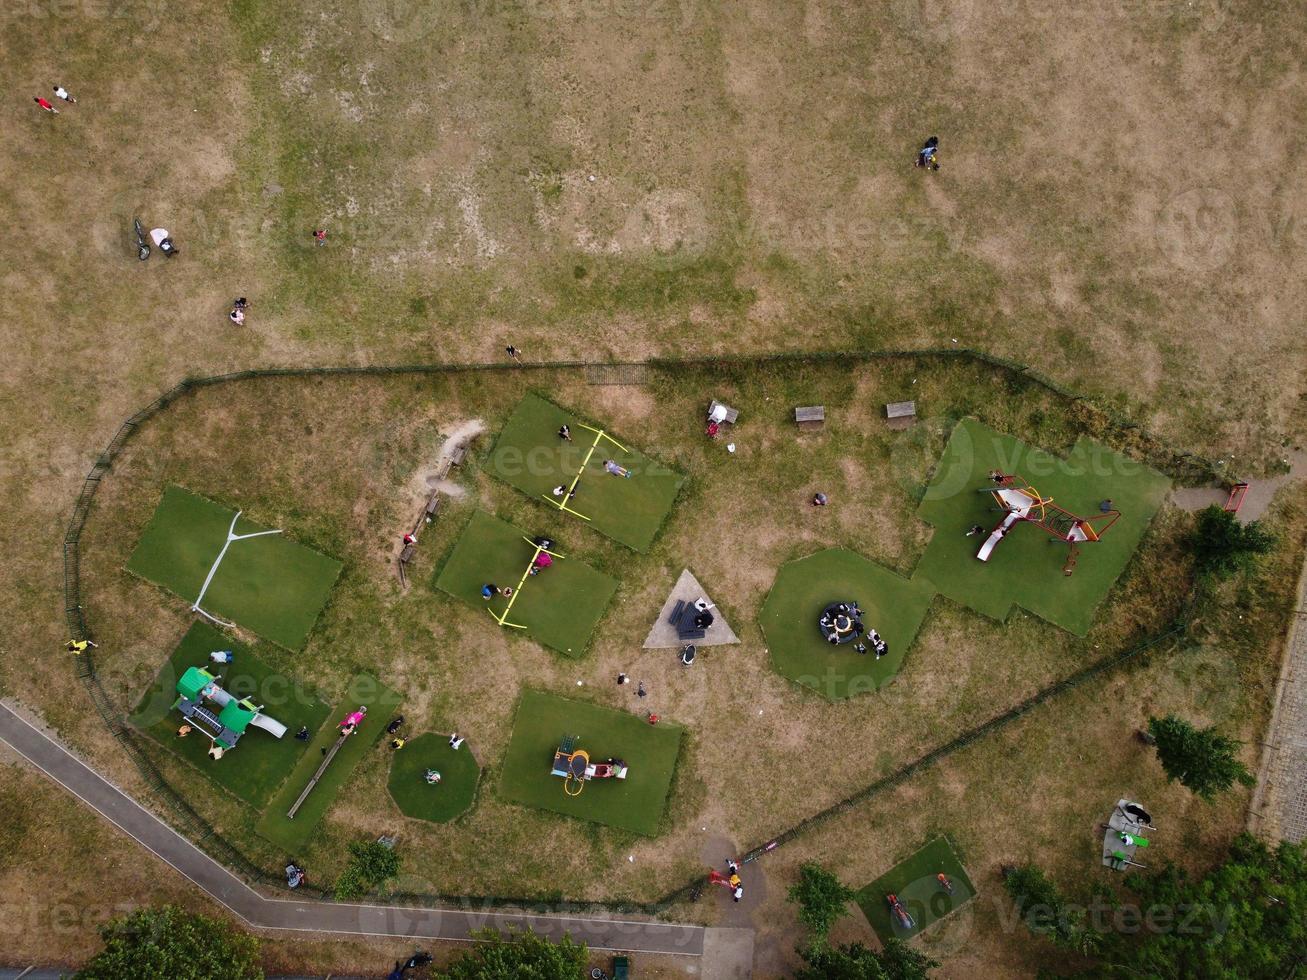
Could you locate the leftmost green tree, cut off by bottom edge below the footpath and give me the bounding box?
[76,906,263,980]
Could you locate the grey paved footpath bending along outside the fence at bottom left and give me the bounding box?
[0,700,704,956]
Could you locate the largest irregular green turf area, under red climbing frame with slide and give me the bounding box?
[914,421,1171,636]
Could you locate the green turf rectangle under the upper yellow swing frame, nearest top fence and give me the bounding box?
[486,393,685,551]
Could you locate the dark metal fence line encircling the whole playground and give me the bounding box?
[63,348,1202,915]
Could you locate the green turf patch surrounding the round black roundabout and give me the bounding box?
[758,549,935,700]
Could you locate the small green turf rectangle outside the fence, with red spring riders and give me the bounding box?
[853,838,976,942]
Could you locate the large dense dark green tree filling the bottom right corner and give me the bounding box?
[1110,834,1307,980]
